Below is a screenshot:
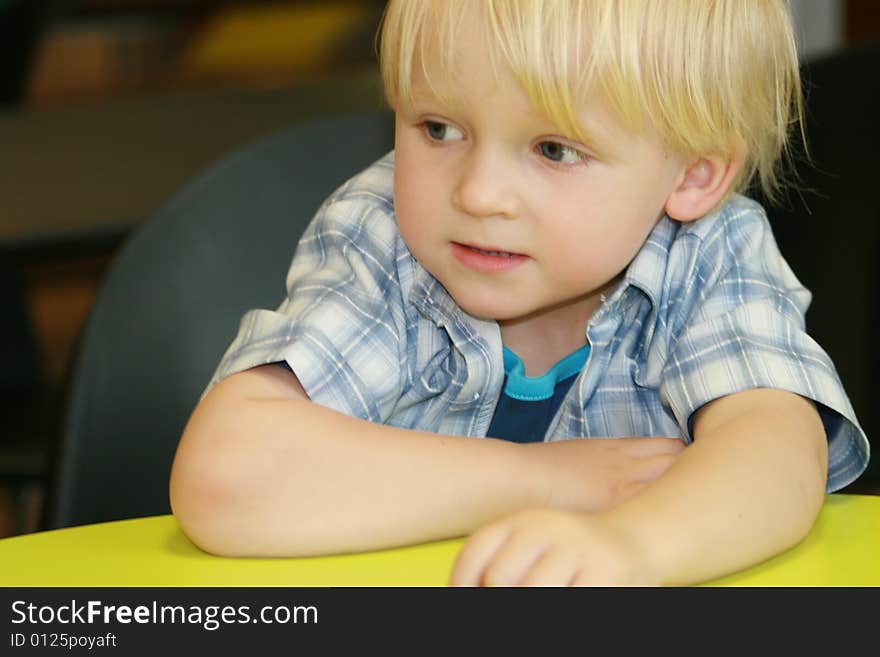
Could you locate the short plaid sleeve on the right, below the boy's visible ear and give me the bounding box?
[660,204,869,492]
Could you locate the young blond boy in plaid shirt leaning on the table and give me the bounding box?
[171,0,868,585]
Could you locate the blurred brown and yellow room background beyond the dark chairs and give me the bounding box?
[0,0,880,536]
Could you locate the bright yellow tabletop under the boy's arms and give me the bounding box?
[0,495,880,586]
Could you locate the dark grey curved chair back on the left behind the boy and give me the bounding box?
[44,112,393,528]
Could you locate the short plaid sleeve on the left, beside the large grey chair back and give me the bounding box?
[209,174,406,422]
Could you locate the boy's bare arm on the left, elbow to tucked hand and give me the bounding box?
[170,365,682,556]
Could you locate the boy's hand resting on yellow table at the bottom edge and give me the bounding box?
[450,509,657,586]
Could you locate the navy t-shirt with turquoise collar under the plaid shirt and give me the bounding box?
[486,344,590,443]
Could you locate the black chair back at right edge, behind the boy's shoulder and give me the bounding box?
[752,43,880,494]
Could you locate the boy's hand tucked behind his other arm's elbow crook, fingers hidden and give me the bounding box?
[523,438,685,511]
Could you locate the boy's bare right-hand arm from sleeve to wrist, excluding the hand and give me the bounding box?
[604,390,827,585]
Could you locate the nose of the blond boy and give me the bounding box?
[452,149,517,219]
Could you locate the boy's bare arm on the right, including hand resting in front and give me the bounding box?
[452,389,827,585]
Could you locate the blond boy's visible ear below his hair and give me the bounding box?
[664,148,745,221]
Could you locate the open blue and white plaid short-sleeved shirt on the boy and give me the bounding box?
[209,153,868,492]
